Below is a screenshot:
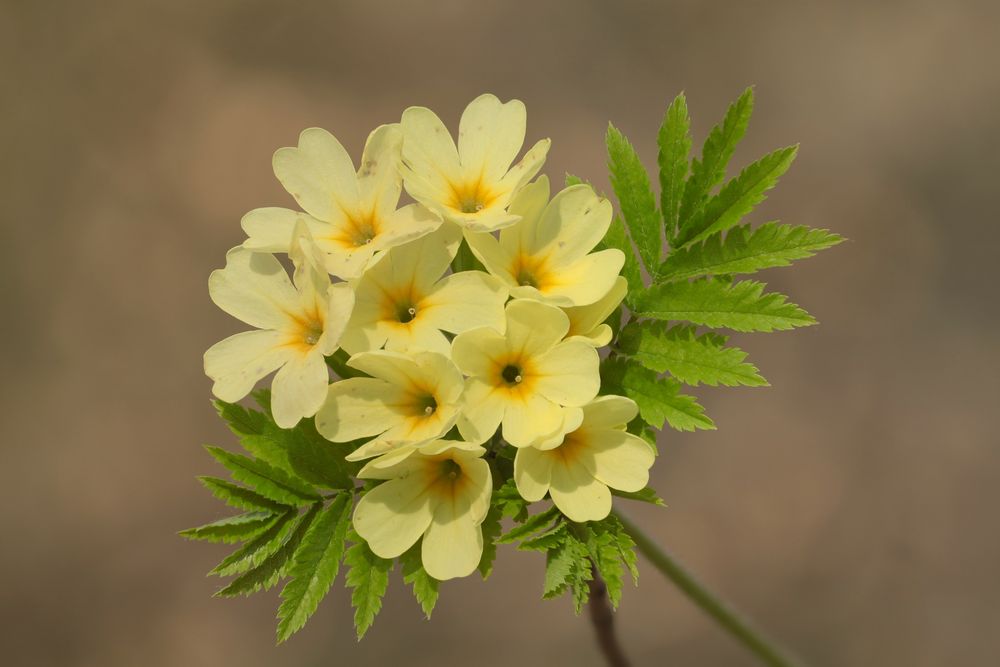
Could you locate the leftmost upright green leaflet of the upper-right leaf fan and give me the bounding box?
[607,123,663,274]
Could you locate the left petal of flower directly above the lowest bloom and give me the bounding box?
[316,378,406,442]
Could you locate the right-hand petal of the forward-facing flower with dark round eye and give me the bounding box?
[534,340,601,406]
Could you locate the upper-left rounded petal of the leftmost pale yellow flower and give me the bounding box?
[208,248,299,329]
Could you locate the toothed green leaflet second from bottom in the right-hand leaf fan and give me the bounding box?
[619,322,767,387]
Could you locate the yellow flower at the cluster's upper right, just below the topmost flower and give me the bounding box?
[466,176,625,307]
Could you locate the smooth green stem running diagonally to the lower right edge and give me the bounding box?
[615,511,800,667]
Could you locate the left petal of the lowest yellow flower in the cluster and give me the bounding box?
[354,477,433,558]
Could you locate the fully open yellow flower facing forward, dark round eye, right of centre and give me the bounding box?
[452,299,601,447]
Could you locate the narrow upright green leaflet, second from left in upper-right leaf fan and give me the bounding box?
[657,93,691,238]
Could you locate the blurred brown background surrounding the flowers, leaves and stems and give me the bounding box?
[0,0,1000,667]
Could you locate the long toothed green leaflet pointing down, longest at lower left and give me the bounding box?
[278,492,353,644]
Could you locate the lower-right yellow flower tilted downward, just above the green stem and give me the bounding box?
[514,396,655,521]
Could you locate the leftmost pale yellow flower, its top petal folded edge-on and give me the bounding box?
[205,223,354,428]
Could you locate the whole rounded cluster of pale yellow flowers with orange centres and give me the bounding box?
[205,95,654,580]
